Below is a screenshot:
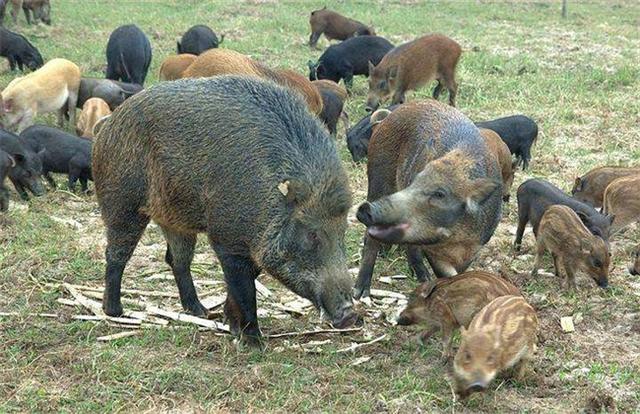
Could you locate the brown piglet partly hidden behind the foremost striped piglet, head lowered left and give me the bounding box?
[398,271,520,359]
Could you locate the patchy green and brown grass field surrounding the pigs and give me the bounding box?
[0,0,640,412]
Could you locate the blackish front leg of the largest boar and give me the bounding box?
[214,245,261,346]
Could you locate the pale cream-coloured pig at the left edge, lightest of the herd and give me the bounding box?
[2,59,80,133]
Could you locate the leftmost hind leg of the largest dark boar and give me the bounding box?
[102,215,149,316]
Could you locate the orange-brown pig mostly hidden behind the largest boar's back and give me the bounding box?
[183,49,322,115]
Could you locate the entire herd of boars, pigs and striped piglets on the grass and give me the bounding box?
[0,4,640,397]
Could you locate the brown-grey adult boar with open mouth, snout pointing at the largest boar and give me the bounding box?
[355,100,502,298]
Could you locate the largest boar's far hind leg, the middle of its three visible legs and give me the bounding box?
[162,227,207,316]
